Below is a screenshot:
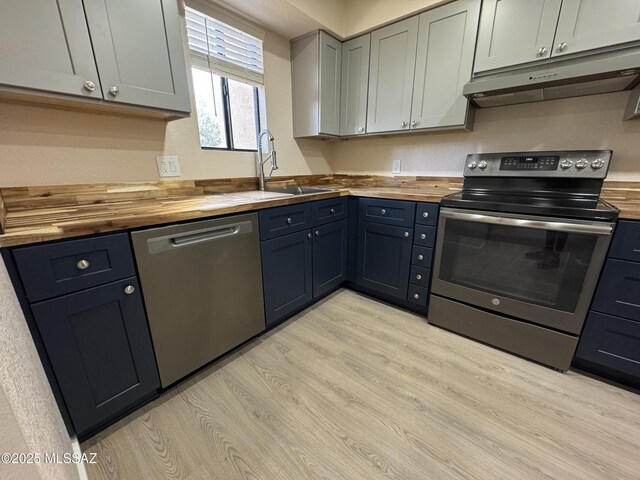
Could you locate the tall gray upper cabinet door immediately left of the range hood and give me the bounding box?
[411,0,480,130]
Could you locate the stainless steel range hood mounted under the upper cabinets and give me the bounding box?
[463,46,640,108]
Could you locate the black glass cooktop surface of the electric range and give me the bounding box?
[441,191,619,220]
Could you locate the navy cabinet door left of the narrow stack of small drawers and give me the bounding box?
[356,222,413,300]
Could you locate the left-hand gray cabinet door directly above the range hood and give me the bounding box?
[474,0,562,72]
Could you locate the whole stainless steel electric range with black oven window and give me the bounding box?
[428,150,618,371]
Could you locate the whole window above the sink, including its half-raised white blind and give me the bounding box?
[186,7,264,151]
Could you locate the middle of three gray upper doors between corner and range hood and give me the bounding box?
[367,16,418,133]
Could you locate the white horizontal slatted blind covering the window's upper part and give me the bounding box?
[186,7,264,86]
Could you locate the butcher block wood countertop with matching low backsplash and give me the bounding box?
[0,175,640,247]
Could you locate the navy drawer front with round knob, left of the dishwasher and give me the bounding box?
[13,233,135,302]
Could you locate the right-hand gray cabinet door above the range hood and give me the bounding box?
[552,0,640,56]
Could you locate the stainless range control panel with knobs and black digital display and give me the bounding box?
[464,150,612,179]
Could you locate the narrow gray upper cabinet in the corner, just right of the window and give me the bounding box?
[291,31,342,138]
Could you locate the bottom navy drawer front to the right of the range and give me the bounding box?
[574,312,640,387]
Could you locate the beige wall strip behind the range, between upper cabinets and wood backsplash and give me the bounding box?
[330,92,640,181]
